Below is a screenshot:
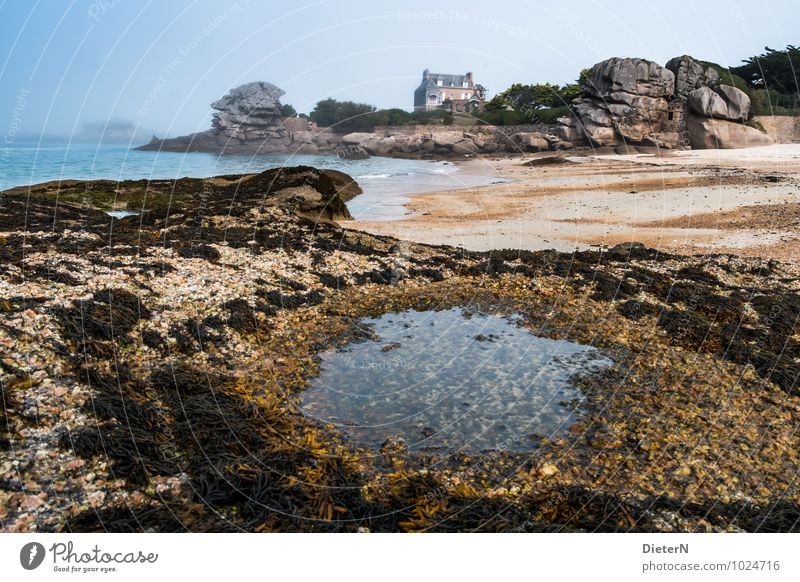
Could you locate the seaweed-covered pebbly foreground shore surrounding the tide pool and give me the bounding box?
[0,168,800,532]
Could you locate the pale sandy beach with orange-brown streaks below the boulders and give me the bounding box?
[354,144,800,261]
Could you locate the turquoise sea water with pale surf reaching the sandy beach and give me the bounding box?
[0,142,498,220]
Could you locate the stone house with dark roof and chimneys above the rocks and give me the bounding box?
[414,69,486,113]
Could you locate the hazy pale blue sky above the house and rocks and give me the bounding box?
[0,0,800,138]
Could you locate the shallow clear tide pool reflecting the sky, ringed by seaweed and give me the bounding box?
[303,309,611,450]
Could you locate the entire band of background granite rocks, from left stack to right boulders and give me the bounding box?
[137,55,774,159]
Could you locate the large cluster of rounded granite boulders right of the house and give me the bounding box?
[556,55,772,148]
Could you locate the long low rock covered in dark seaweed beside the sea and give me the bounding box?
[0,166,361,229]
